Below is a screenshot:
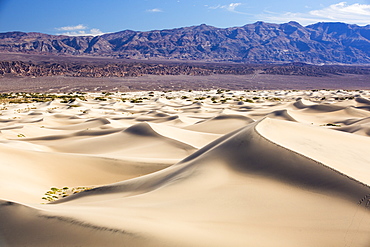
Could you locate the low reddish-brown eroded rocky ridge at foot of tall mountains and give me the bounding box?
[0,61,370,78]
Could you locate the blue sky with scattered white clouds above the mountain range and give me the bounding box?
[0,0,370,36]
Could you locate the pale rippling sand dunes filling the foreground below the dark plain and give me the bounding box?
[0,90,370,247]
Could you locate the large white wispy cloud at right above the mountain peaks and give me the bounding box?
[257,2,370,25]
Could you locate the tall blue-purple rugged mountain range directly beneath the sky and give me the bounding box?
[0,22,370,64]
